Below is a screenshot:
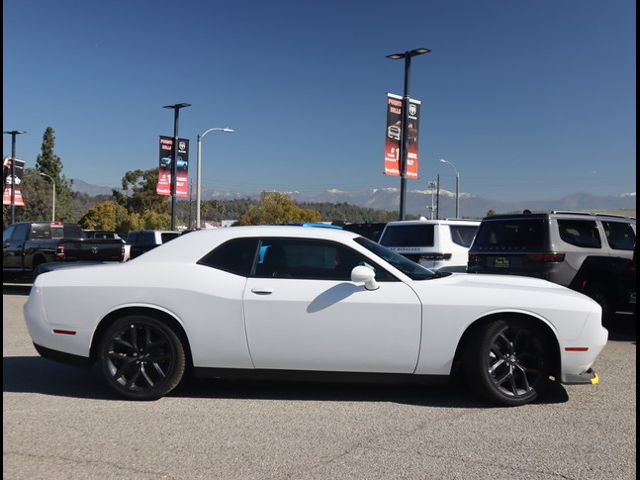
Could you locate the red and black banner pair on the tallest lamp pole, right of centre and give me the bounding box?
[384,93,421,178]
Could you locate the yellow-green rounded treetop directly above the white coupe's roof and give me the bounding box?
[237,192,321,225]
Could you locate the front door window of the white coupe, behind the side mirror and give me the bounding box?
[253,238,395,281]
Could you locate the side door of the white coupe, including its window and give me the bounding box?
[243,238,421,373]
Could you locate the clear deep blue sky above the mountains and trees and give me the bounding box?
[2,0,636,200]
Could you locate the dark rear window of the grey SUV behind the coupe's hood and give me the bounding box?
[473,218,548,251]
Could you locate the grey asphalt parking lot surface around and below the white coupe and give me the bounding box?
[3,286,636,480]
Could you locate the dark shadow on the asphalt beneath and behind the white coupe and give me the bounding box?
[2,356,569,409]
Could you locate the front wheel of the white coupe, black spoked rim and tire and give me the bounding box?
[464,320,552,406]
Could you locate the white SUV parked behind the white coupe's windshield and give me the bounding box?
[379,219,480,272]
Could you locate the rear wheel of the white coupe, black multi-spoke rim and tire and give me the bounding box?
[98,315,186,400]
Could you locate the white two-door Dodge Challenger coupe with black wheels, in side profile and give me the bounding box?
[24,226,608,405]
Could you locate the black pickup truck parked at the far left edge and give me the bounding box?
[2,222,124,278]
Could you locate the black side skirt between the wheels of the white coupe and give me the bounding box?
[194,367,449,385]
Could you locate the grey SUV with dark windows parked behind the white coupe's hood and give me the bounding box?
[468,211,636,319]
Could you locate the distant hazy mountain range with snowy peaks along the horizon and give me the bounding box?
[73,179,636,218]
